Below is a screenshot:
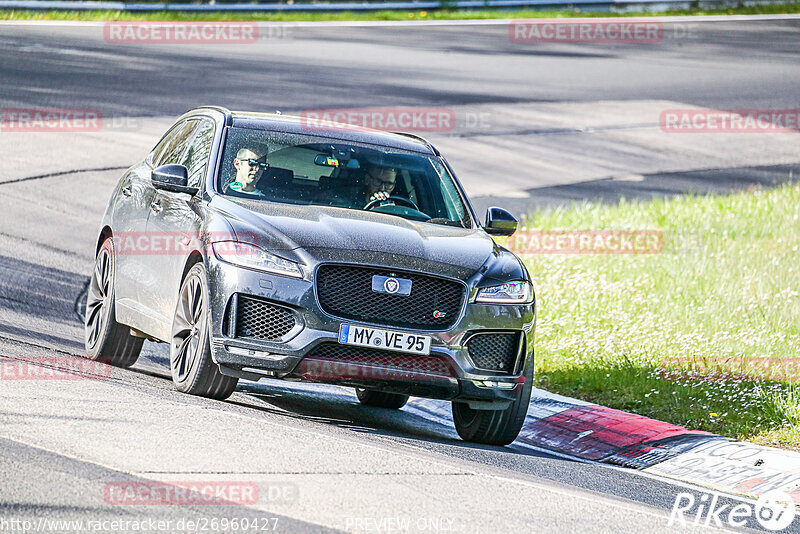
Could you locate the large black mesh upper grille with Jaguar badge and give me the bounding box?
[317,265,465,330]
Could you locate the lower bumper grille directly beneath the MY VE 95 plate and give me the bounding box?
[305,343,454,379]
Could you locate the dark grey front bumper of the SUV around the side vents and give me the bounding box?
[207,255,535,407]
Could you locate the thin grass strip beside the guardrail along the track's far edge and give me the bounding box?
[0,2,800,22]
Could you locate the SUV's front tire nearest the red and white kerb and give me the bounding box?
[453,365,533,446]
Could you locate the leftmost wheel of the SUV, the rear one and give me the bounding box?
[84,237,144,367]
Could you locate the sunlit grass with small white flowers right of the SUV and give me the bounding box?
[512,184,800,449]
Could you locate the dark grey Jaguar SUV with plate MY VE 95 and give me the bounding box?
[86,107,535,444]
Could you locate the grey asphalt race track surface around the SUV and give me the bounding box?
[0,16,800,532]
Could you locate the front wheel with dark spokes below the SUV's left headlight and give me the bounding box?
[169,263,239,400]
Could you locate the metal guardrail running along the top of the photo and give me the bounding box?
[0,0,780,12]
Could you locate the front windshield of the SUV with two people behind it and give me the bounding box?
[217,127,471,227]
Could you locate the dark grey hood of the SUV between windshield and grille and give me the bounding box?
[211,196,500,279]
